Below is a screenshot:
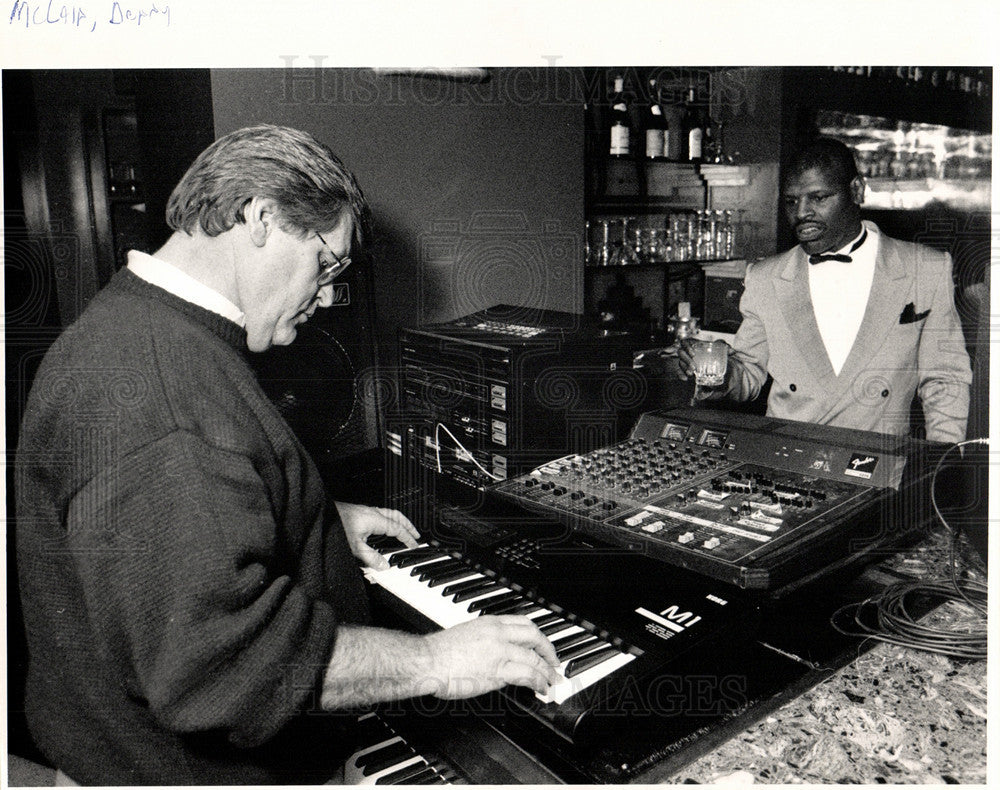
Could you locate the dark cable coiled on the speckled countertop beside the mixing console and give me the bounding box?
[830,439,988,660]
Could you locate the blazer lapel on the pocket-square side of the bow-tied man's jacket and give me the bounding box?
[824,234,909,406]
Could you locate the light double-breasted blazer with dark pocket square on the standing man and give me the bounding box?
[727,224,972,442]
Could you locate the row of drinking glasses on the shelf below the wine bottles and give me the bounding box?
[584,209,742,271]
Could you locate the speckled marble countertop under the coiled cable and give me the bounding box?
[670,530,987,784]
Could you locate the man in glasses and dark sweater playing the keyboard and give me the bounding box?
[16,126,559,785]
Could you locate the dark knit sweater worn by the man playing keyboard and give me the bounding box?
[16,270,368,784]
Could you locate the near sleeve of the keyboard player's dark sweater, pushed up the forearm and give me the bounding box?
[67,431,336,746]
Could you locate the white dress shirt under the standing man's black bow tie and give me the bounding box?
[807,222,879,376]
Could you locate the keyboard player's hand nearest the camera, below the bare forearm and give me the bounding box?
[424,615,559,699]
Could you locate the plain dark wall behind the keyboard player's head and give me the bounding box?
[212,69,584,372]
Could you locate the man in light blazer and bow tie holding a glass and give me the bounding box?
[680,138,972,442]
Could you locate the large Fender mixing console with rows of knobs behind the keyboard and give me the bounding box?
[492,410,932,590]
